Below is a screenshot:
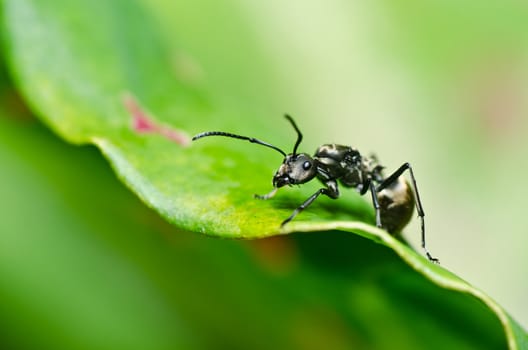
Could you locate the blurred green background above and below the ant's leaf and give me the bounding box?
[0,0,528,349]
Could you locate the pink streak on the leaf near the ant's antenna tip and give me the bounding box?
[123,94,191,146]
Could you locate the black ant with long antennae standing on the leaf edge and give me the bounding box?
[192,115,438,263]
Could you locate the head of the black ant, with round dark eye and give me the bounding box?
[273,153,317,187]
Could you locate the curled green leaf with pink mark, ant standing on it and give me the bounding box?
[3,0,527,349]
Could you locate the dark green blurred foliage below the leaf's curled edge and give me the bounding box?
[0,111,522,350]
